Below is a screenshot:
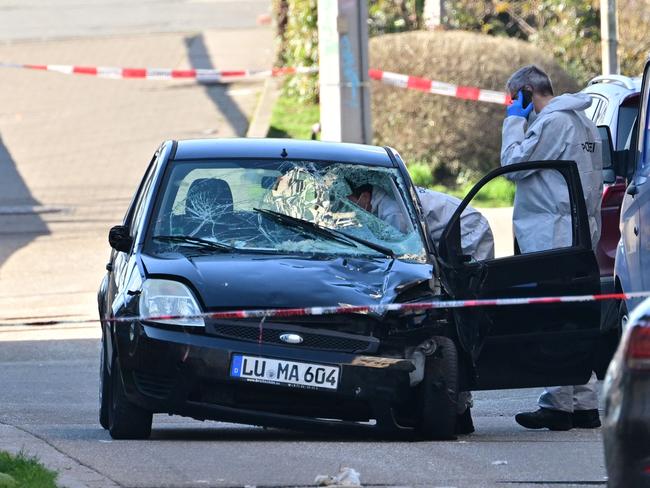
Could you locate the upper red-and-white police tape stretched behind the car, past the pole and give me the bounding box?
[0,63,510,105]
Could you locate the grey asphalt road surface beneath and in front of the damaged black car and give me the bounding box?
[0,329,605,488]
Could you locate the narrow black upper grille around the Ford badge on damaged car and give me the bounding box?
[210,323,379,353]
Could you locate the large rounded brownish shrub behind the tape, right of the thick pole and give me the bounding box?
[370,31,577,185]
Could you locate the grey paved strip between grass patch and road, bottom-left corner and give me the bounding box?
[0,422,120,488]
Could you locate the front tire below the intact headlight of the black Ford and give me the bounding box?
[108,361,153,439]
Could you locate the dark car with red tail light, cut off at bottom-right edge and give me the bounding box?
[603,299,650,488]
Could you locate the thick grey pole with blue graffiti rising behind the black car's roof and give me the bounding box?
[318,0,372,144]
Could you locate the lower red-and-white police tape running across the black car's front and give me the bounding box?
[0,291,650,327]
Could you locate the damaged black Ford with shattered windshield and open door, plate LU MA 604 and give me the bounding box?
[98,139,609,439]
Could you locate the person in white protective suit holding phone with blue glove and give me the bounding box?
[501,65,603,430]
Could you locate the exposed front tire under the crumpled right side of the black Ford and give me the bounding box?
[416,336,458,440]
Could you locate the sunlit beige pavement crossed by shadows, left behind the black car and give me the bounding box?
[0,27,273,321]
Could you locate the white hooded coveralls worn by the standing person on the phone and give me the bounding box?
[501,93,603,412]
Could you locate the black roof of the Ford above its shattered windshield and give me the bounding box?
[173,138,394,166]
